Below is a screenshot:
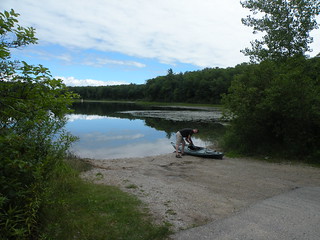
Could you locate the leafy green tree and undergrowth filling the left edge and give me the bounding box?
[0,10,75,239]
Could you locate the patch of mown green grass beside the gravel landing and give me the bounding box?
[39,159,170,240]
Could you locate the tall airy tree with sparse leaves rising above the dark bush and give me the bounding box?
[241,0,320,62]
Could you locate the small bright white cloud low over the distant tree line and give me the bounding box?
[55,76,128,87]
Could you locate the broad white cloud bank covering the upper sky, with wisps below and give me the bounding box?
[2,0,320,68]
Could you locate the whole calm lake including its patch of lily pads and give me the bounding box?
[66,102,224,159]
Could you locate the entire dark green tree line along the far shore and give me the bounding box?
[69,64,247,104]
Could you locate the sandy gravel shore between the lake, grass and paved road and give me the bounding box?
[82,153,320,231]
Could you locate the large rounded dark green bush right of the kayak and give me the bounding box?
[223,57,320,158]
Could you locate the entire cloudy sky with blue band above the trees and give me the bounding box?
[0,0,320,86]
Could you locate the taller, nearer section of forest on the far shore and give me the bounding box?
[145,68,233,103]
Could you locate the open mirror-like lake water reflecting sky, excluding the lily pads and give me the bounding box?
[66,103,222,159]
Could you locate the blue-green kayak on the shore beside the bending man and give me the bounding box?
[171,142,223,159]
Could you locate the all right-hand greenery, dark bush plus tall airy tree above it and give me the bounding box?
[223,0,320,161]
